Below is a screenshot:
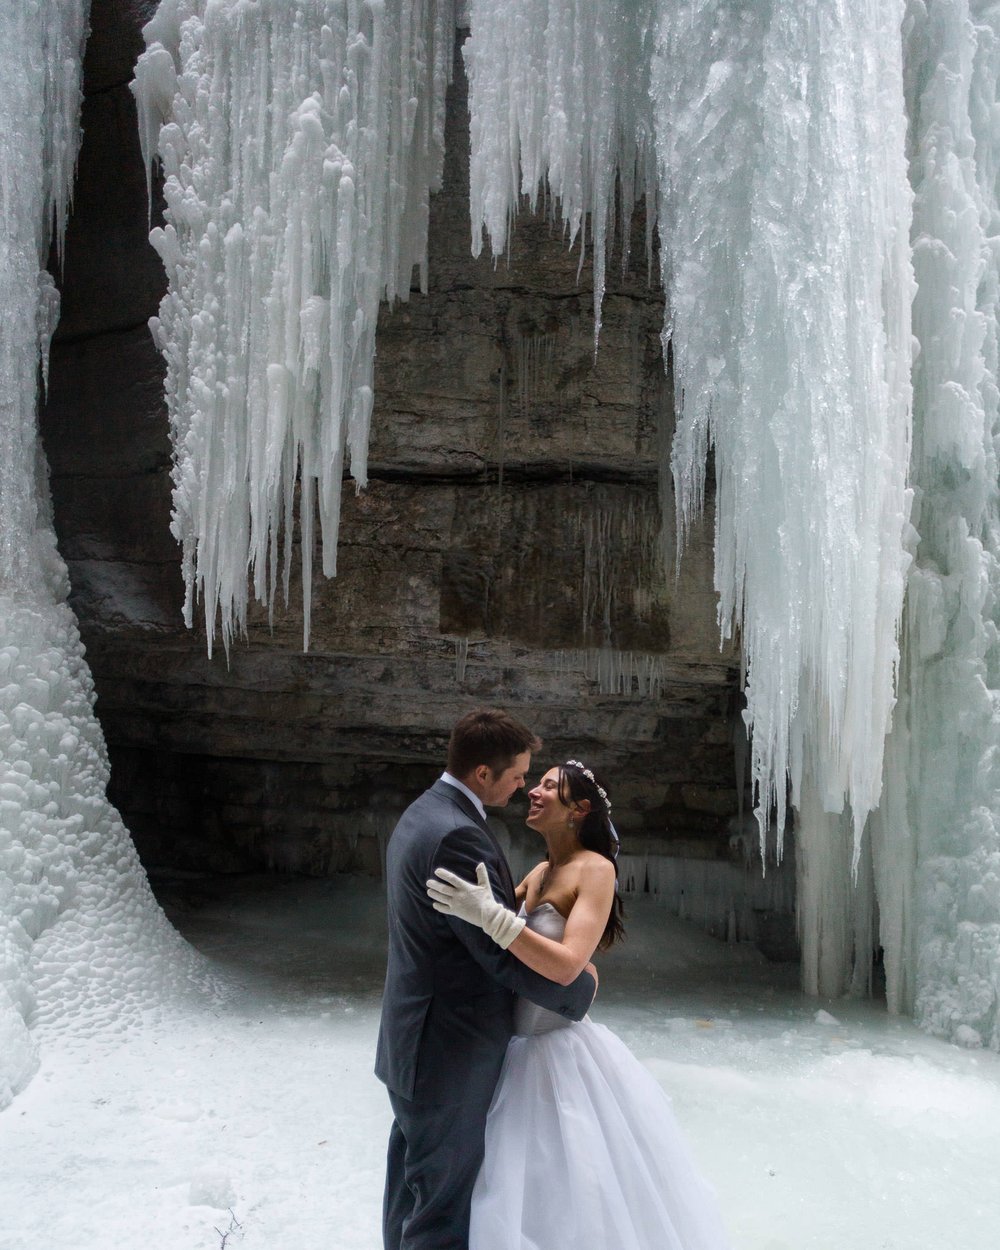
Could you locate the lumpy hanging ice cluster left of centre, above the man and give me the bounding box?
[133,0,455,648]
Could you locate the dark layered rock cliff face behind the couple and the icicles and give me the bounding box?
[44,0,760,910]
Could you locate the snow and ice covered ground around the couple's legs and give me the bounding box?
[0,878,1000,1250]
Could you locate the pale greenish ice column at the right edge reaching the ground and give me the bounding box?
[874,0,1000,1049]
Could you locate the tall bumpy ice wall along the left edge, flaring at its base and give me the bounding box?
[0,0,190,1108]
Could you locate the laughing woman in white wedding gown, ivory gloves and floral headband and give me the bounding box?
[428,760,730,1250]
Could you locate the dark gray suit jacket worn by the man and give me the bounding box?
[375,780,596,1106]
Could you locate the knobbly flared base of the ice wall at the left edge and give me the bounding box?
[0,595,211,1050]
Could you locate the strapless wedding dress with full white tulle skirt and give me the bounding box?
[469,903,730,1250]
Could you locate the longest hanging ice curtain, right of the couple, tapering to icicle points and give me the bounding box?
[653,3,913,854]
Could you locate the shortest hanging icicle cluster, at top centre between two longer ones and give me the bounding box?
[464,0,656,350]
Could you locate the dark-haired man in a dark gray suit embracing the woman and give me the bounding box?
[375,709,596,1250]
